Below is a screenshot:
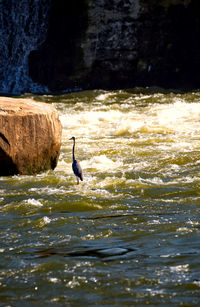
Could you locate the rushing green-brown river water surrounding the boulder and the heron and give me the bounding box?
[0,89,200,306]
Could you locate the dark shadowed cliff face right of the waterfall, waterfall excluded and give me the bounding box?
[29,0,200,91]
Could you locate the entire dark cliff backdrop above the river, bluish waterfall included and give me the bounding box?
[0,0,200,93]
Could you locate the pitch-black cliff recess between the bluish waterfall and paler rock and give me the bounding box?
[29,0,88,92]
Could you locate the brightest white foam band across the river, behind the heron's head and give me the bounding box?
[61,99,200,141]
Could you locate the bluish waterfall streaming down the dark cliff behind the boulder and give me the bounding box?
[0,0,51,94]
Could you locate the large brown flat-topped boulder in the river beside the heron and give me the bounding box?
[0,97,62,176]
